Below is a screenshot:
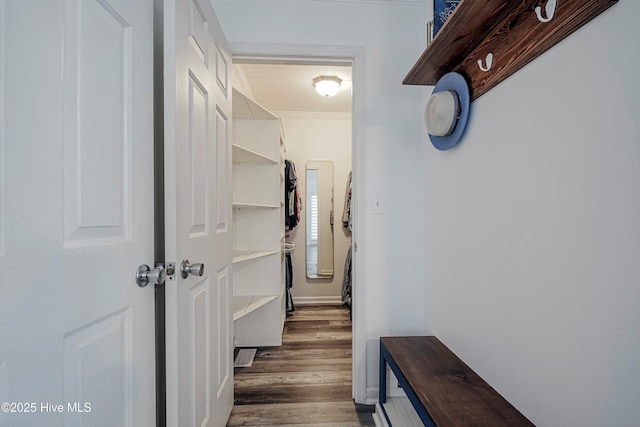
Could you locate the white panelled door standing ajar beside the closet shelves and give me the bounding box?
[164,0,233,427]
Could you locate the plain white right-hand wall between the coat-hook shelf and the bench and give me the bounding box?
[423,1,640,426]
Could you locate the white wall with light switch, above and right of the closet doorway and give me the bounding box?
[212,0,426,401]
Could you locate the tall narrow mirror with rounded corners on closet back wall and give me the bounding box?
[305,160,333,279]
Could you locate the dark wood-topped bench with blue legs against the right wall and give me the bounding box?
[379,336,533,427]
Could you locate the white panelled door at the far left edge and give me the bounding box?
[0,0,155,427]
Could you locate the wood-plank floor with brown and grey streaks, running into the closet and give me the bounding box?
[227,305,374,427]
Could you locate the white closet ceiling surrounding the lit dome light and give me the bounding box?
[234,63,351,113]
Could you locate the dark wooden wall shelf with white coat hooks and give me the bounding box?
[403,0,618,101]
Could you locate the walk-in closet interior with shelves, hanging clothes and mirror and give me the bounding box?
[233,60,353,422]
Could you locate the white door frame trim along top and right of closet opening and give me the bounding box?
[229,42,367,404]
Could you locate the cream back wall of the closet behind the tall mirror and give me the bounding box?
[275,112,351,302]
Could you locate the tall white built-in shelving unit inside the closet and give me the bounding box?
[232,89,286,347]
